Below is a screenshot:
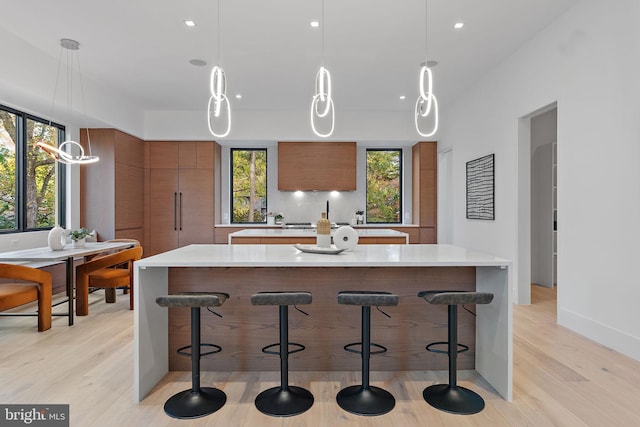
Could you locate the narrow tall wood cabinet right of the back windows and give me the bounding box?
[412,141,438,243]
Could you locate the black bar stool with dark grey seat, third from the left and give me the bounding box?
[336,291,398,415]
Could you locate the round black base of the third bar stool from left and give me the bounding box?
[336,385,396,415]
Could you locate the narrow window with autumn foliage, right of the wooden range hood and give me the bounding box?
[367,149,402,223]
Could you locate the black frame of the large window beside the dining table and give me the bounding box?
[0,104,67,234]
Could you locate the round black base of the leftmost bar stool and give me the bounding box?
[164,387,227,419]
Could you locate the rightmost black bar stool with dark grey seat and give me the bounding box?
[418,291,493,415]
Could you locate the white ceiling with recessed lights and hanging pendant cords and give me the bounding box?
[0,0,578,118]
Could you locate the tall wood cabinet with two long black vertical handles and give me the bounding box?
[145,141,220,255]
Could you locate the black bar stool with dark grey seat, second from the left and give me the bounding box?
[251,292,313,417]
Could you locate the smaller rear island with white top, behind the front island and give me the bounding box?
[229,228,409,245]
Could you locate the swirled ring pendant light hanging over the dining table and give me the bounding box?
[36,39,100,165]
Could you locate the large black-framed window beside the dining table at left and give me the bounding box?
[0,105,64,232]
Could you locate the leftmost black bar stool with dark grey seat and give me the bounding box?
[156,292,229,419]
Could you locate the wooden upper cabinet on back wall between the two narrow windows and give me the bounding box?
[278,142,356,191]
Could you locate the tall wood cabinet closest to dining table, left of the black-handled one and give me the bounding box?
[80,129,144,241]
